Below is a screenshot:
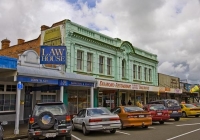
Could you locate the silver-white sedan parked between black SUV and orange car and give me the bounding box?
[72,107,121,135]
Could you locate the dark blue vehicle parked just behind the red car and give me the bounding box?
[148,99,182,121]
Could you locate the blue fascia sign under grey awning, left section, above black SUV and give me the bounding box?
[17,76,58,85]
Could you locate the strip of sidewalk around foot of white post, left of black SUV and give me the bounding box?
[3,124,28,140]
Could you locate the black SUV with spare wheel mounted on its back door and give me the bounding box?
[28,102,72,140]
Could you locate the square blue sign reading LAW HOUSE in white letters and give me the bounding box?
[40,46,67,64]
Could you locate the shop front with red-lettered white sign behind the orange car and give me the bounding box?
[97,80,159,109]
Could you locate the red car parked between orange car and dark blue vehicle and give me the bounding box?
[143,104,170,124]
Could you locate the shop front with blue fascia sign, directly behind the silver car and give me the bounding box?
[59,79,96,115]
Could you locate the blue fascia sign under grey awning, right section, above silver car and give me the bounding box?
[58,80,94,87]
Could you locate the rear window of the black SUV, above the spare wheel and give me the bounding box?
[33,104,67,116]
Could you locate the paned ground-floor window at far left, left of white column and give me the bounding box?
[0,94,16,111]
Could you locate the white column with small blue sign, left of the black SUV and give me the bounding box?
[14,82,21,134]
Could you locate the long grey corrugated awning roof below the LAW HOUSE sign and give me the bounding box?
[17,65,96,83]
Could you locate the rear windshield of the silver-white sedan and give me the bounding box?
[87,108,111,116]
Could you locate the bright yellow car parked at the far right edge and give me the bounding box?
[181,104,200,117]
